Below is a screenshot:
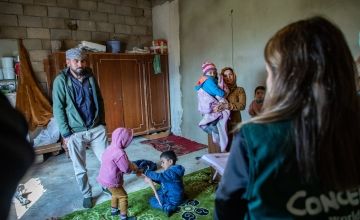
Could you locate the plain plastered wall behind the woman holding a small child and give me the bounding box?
[179,0,360,143]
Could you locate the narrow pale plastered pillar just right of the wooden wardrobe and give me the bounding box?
[152,0,183,135]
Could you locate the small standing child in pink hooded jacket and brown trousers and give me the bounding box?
[97,128,137,220]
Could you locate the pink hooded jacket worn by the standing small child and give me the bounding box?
[96,128,133,188]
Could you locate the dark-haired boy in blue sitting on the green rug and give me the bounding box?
[144,150,185,216]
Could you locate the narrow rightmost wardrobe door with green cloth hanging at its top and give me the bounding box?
[145,55,170,133]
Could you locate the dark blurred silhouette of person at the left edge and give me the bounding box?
[0,92,35,219]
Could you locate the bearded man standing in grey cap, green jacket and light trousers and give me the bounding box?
[52,48,107,208]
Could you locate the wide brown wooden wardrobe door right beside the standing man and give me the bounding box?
[91,53,147,135]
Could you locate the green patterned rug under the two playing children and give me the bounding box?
[60,168,216,220]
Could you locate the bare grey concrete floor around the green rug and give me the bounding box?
[9,138,207,220]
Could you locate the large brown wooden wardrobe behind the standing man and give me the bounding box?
[47,53,170,135]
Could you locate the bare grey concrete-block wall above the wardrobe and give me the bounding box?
[0,0,152,90]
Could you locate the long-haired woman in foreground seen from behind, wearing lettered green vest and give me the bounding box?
[215,17,360,219]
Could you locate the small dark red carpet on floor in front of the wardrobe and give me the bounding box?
[140,135,207,156]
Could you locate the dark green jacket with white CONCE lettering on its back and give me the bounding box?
[215,121,360,220]
